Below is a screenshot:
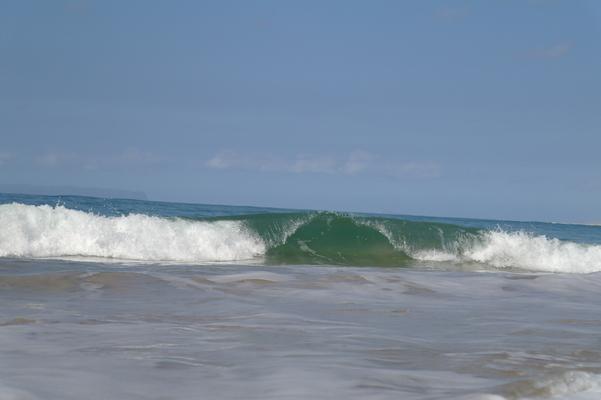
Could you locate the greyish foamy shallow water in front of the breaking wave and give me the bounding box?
[0,259,601,399]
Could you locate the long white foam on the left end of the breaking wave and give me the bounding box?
[0,203,265,262]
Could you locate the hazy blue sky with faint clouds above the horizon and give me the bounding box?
[0,0,601,223]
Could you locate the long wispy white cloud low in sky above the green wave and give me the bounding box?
[205,150,440,178]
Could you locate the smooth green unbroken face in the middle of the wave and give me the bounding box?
[229,212,478,266]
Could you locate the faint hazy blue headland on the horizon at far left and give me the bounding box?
[0,183,148,200]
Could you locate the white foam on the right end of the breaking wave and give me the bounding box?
[463,231,601,273]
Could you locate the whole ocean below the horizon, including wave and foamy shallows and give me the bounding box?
[0,194,601,400]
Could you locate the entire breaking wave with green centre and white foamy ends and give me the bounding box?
[0,203,601,273]
